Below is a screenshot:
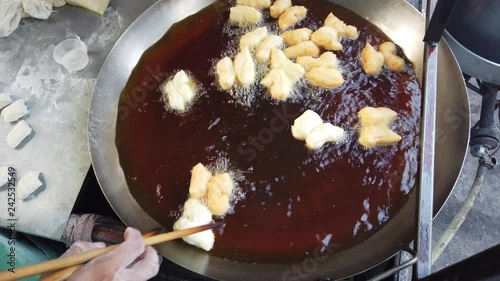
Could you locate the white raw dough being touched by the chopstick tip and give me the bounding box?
[173,198,215,251]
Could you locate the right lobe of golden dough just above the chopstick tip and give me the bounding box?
[207,173,233,216]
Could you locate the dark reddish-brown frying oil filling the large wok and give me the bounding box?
[116,0,420,262]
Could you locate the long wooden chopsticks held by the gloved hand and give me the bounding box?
[0,222,224,281]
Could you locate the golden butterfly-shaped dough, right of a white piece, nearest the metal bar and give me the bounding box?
[358,107,402,148]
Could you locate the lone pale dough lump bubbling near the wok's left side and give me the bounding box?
[161,70,196,112]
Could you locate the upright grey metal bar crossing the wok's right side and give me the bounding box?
[414,0,439,279]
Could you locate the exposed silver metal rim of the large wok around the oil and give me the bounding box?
[89,0,470,280]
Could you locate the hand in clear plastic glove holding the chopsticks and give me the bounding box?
[57,227,161,281]
